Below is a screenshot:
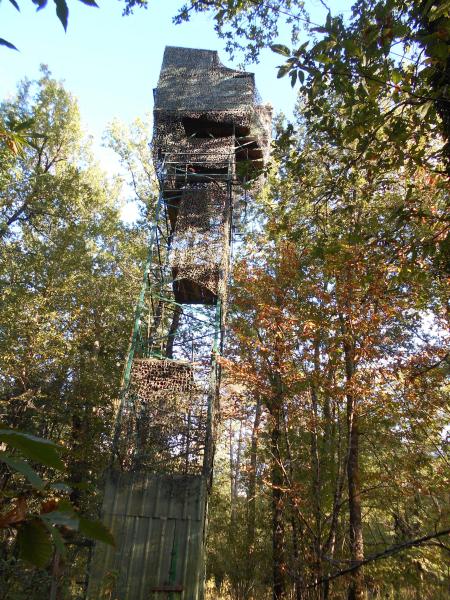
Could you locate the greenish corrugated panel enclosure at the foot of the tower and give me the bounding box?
[87,472,206,600]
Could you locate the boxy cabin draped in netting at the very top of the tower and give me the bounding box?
[153,46,271,176]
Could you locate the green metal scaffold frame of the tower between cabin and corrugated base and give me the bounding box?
[113,153,233,478]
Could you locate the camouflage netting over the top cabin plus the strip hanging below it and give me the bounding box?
[153,47,271,304]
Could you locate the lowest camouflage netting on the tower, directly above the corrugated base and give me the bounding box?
[118,359,208,473]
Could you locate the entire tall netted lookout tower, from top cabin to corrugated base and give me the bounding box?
[88,47,271,600]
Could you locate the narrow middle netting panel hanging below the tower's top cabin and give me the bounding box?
[169,184,230,304]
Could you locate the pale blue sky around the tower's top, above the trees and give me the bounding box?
[0,0,351,216]
